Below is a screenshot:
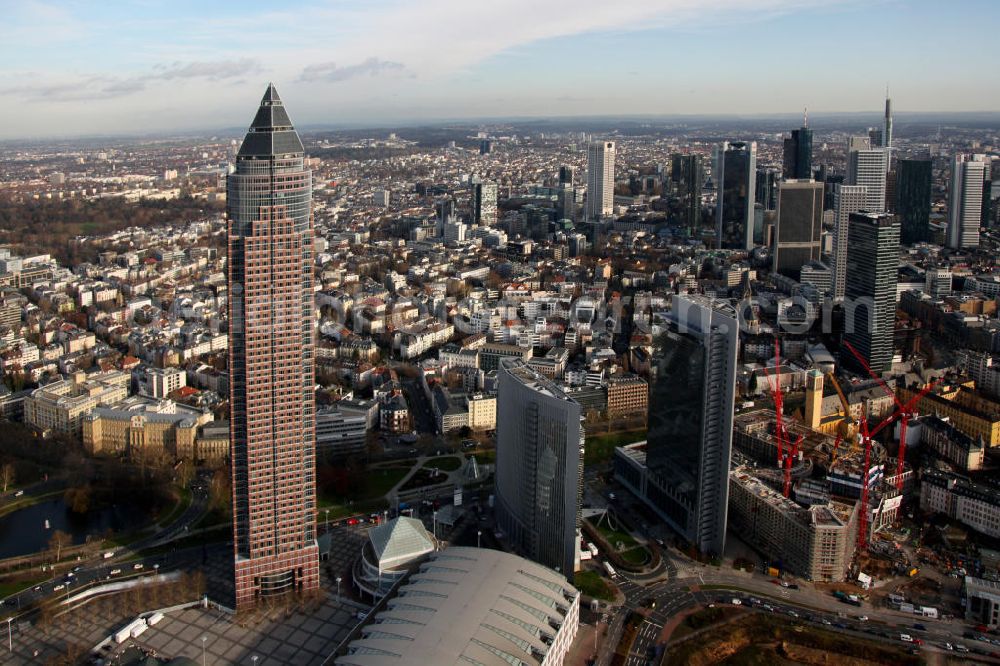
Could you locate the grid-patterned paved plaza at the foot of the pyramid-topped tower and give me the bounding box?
[0,526,369,666]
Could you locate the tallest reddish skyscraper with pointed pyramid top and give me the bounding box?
[226,85,319,609]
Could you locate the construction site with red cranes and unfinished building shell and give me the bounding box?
[729,341,930,582]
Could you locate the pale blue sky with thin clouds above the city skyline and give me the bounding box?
[0,0,1000,139]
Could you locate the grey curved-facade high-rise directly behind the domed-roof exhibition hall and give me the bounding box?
[496,359,584,578]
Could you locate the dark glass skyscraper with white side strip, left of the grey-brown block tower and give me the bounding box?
[713,141,757,250]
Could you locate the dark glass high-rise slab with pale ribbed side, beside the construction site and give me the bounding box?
[644,296,739,555]
